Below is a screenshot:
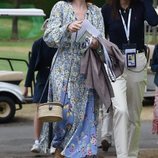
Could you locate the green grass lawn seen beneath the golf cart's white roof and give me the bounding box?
[0,17,43,73]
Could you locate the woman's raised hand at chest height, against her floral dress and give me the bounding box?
[67,20,83,32]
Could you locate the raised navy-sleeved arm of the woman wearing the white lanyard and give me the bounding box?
[143,0,158,26]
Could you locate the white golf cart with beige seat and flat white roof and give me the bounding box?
[0,9,45,123]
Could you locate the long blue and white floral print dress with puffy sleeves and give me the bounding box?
[41,1,104,158]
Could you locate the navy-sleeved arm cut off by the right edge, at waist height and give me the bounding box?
[151,45,158,72]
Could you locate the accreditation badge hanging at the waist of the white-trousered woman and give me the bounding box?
[123,43,137,68]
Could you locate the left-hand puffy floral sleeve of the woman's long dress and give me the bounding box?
[43,1,70,47]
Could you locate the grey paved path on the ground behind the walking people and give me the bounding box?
[0,105,158,158]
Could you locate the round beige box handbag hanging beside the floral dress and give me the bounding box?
[38,102,63,122]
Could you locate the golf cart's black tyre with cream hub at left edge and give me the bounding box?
[0,96,15,123]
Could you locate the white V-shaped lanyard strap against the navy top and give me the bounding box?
[119,9,132,42]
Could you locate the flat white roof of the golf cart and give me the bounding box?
[0,8,46,16]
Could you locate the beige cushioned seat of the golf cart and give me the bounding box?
[0,70,24,85]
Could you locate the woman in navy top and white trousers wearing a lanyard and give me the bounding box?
[102,0,158,158]
